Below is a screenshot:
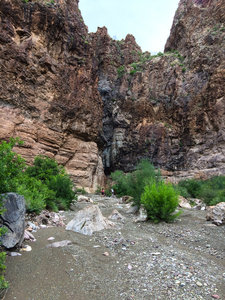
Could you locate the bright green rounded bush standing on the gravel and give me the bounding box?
[141,181,181,222]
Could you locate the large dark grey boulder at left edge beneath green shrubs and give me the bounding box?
[0,193,26,249]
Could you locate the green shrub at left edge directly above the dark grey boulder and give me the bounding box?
[0,139,25,194]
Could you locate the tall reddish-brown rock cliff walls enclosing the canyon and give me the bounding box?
[0,0,225,189]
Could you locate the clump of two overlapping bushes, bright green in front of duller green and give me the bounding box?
[111,160,179,222]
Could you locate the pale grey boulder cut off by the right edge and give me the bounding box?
[206,202,225,225]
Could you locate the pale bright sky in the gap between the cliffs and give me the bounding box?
[79,0,179,54]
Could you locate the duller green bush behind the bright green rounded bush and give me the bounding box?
[111,160,160,207]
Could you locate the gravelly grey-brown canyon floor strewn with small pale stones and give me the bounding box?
[5,195,225,300]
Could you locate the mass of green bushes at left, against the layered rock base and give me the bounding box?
[0,139,75,213]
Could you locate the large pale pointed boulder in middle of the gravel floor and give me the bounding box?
[66,205,115,235]
